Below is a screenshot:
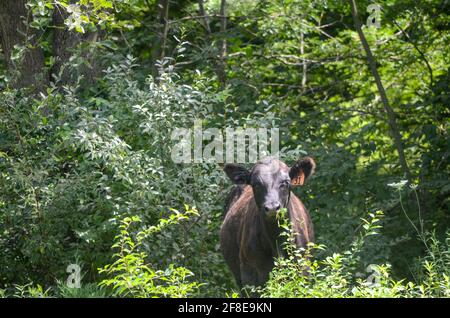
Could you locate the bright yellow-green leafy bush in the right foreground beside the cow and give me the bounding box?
[260,211,450,298]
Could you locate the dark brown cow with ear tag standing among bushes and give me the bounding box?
[220,157,316,289]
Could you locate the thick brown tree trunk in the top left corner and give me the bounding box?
[0,0,48,91]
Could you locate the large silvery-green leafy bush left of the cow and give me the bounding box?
[0,54,231,294]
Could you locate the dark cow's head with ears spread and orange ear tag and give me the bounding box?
[224,157,316,214]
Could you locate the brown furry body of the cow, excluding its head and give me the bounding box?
[220,185,314,288]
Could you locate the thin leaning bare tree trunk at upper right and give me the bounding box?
[350,0,411,181]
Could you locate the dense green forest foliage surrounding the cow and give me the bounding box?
[0,0,450,297]
